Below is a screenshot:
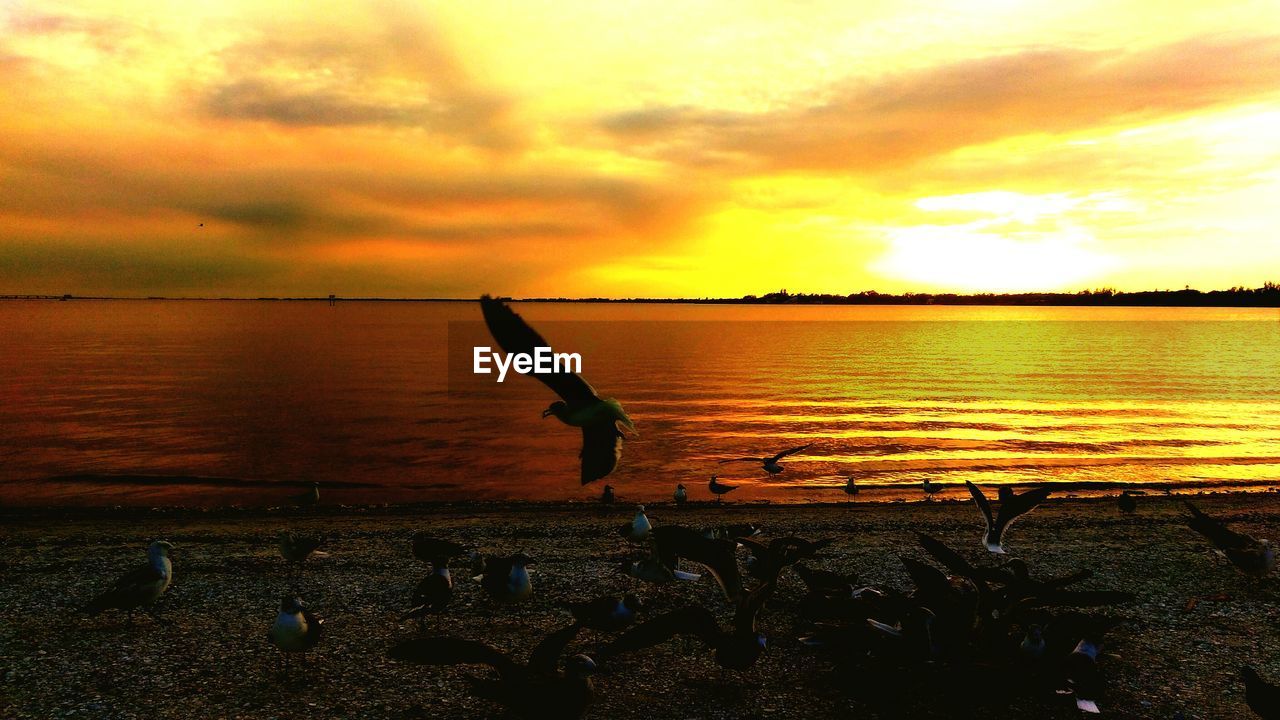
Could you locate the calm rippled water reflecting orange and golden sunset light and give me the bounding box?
[0,301,1280,505]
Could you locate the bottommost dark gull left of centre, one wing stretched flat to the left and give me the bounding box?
[387,623,595,720]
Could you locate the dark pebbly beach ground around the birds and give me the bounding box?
[0,493,1280,720]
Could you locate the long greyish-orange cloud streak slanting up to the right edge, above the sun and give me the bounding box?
[599,36,1280,172]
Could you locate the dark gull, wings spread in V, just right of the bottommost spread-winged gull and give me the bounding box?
[602,578,777,670]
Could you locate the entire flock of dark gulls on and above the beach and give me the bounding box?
[77,297,1280,720]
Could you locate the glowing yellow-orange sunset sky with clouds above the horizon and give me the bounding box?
[0,0,1280,297]
